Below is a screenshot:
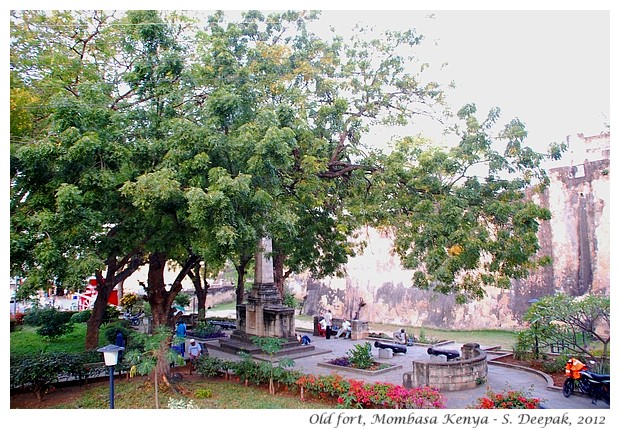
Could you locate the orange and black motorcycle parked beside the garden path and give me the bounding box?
[562,358,611,405]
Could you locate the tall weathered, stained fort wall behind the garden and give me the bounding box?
[298,133,610,329]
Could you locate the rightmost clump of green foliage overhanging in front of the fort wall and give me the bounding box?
[370,105,551,303]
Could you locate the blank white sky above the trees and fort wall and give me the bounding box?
[310,10,610,154]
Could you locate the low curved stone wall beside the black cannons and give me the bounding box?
[403,343,488,391]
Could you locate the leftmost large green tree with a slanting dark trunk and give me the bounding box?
[11,11,153,348]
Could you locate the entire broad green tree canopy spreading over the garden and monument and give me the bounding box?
[11,10,550,325]
